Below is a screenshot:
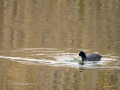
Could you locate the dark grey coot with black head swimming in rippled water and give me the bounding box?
[79,51,102,62]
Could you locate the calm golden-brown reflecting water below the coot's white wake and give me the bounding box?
[2,63,120,90]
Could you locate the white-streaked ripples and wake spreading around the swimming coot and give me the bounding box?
[0,48,120,69]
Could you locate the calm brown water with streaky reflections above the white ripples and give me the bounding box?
[0,0,120,51]
